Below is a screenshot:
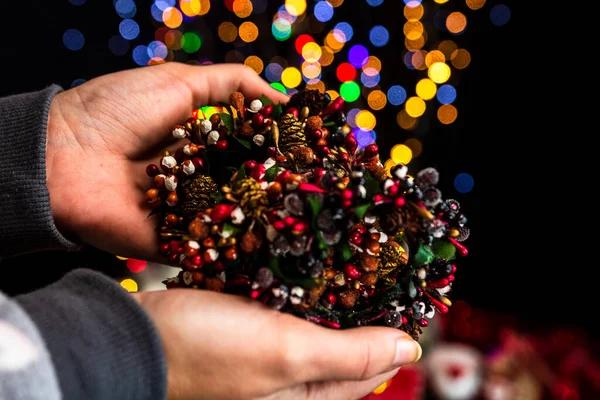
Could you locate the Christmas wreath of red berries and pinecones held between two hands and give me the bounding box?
[146,90,469,339]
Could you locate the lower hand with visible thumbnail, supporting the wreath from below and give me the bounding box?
[134,289,421,400]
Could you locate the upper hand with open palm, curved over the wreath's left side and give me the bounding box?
[46,62,288,260]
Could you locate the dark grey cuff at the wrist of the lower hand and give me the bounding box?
[16,270,167,400]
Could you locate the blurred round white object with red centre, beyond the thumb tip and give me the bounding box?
[423,343,484,400]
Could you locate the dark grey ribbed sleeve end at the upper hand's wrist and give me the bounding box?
[0,85,78,258]
